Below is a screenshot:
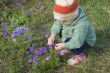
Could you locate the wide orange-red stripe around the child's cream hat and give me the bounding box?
[53,0,78,14]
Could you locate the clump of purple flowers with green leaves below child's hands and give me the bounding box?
[26,47,59,73]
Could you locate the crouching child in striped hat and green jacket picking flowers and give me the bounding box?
[48,0,96,66]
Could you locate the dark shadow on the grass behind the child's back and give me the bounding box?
[87,25,110,54]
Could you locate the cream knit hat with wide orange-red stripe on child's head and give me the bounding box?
[53,0,78,20]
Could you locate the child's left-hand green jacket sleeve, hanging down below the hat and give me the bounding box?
[51,20,62,35]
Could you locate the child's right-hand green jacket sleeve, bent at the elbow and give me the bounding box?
[64,26,87,49]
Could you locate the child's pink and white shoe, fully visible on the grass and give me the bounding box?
[67,53,86,66]
